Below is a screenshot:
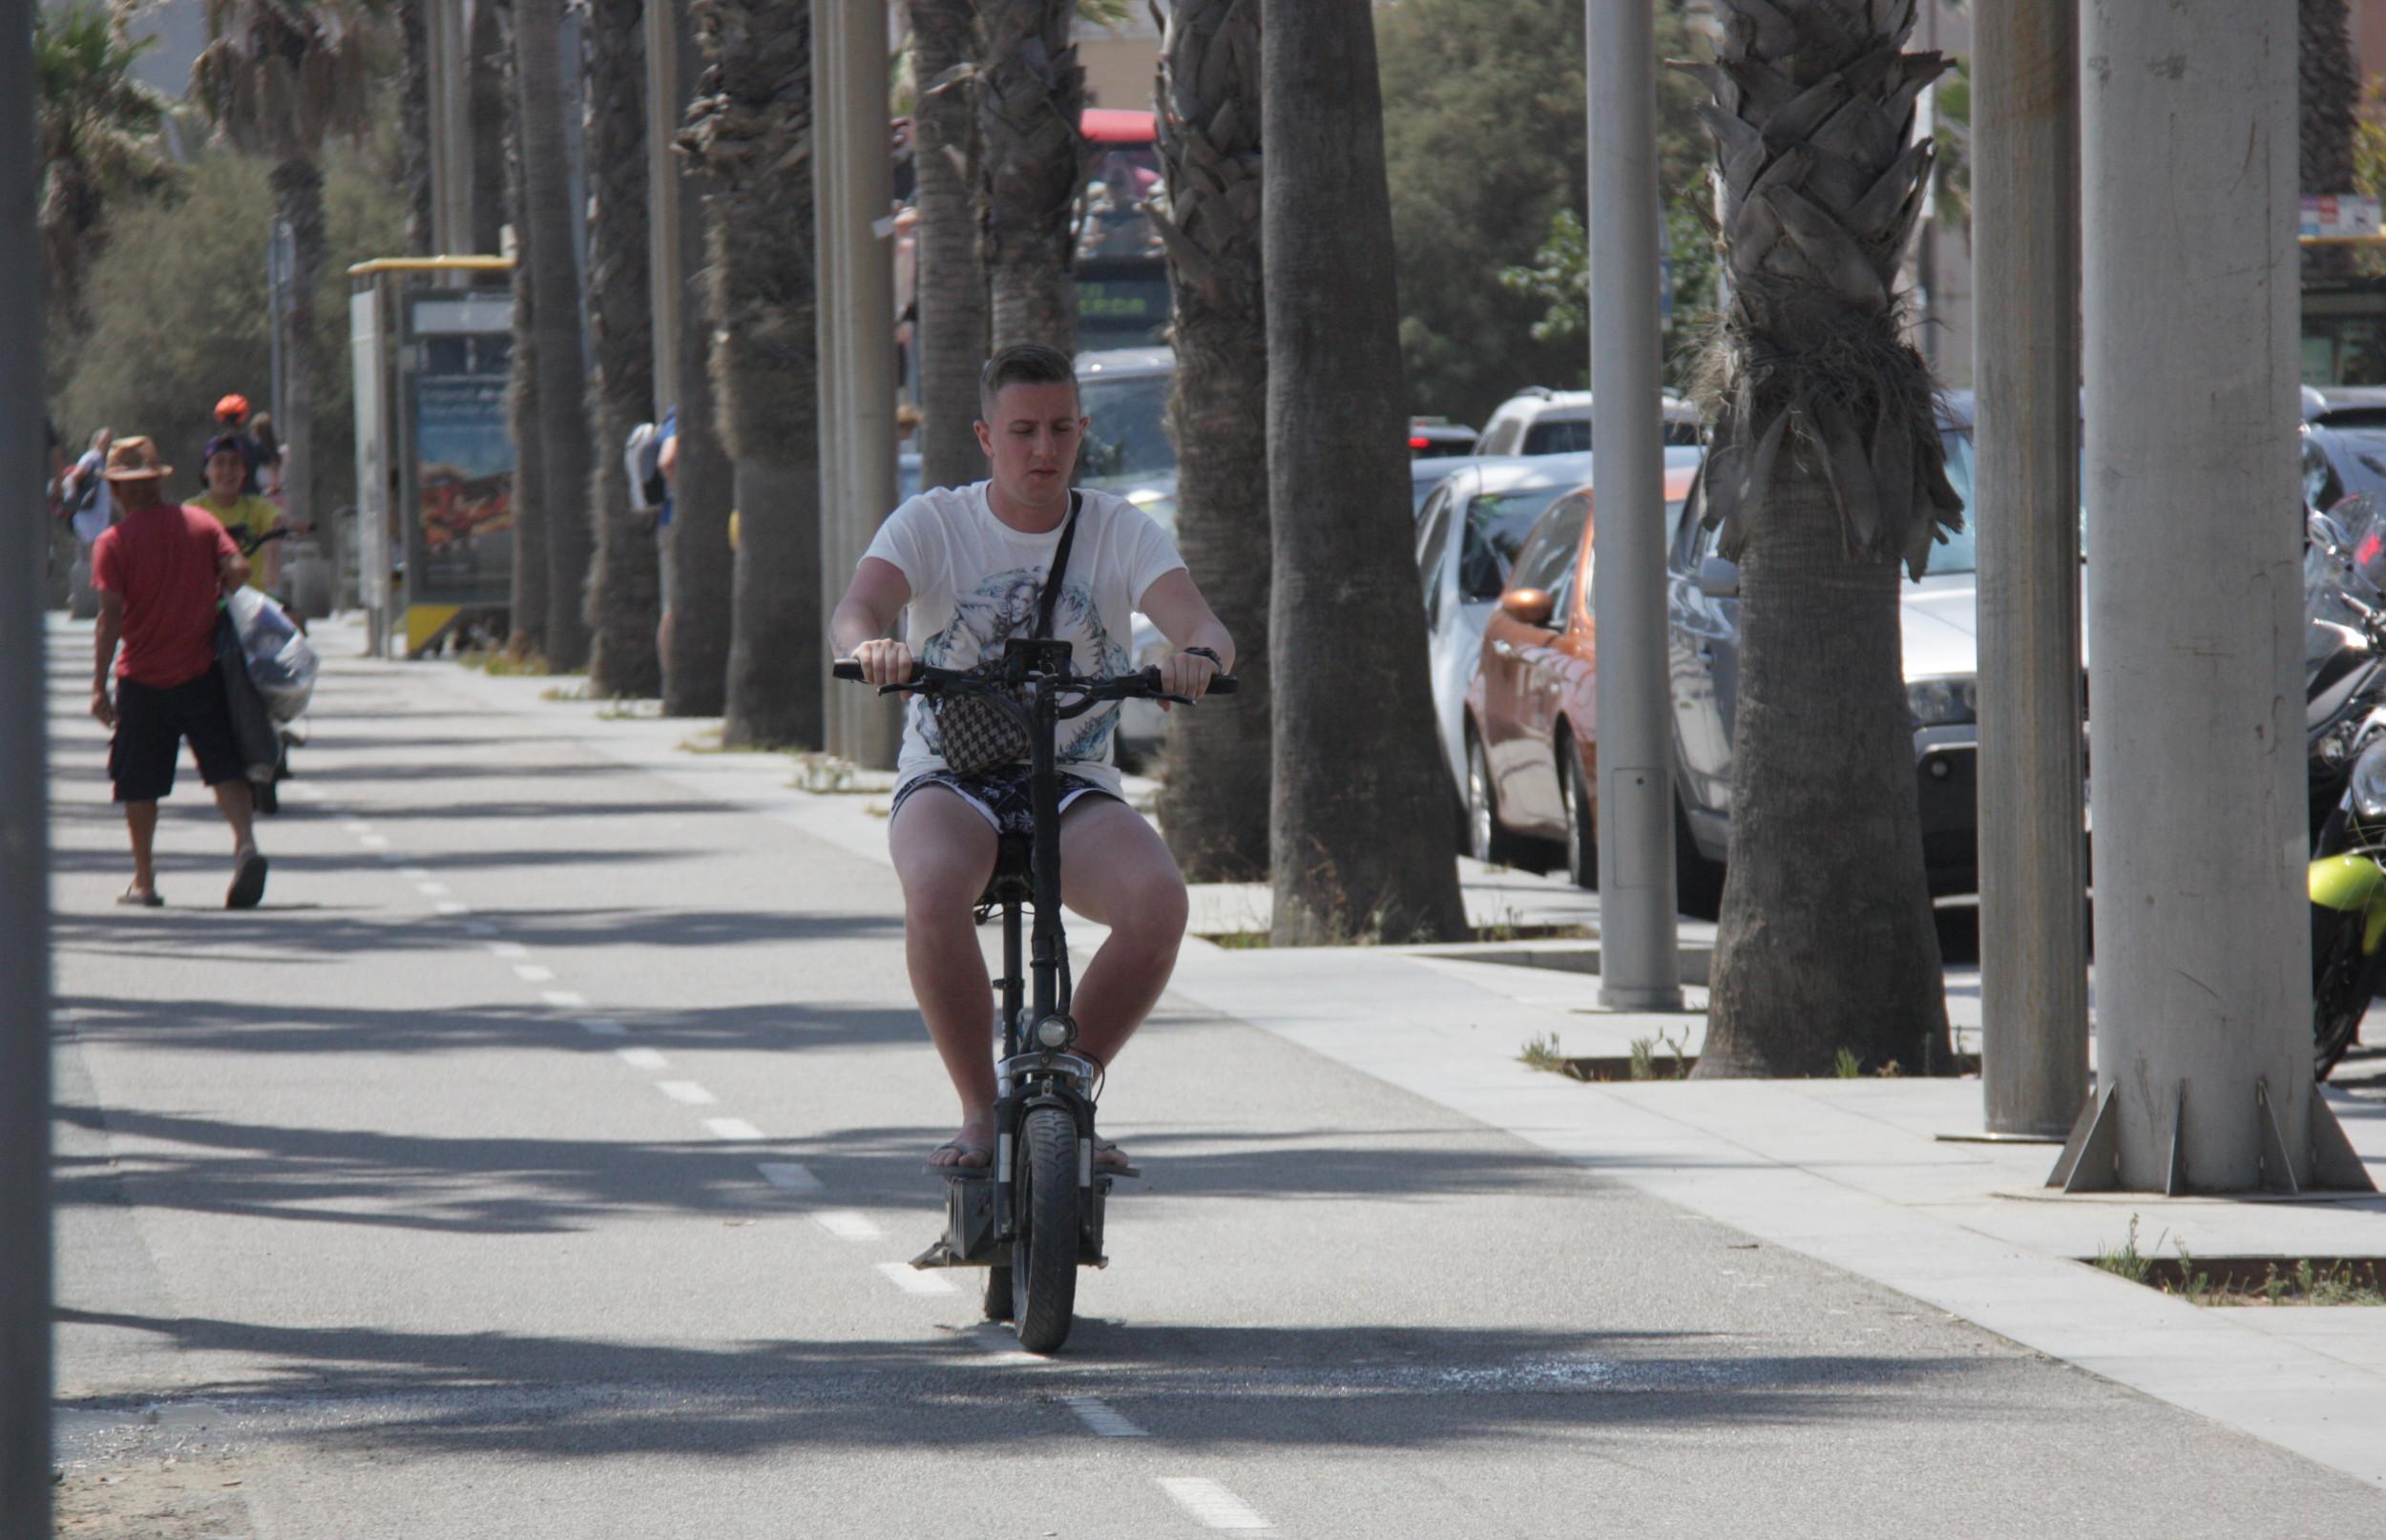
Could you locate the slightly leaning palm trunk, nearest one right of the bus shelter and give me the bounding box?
[513,0,596,673]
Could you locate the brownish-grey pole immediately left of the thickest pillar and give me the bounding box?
[1971,0,2088,1137]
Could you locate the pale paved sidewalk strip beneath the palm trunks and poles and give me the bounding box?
[415,632,2386,1486]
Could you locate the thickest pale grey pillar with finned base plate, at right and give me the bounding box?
[2090,0,2313,1190]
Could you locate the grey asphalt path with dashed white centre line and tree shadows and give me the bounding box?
[51,625,2386,1540]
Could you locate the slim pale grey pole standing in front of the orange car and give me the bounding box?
[1587,0,1683,1010]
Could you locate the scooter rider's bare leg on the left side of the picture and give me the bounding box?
[888,786,995,1166]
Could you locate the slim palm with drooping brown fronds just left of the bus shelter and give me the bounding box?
[191,0,377,610]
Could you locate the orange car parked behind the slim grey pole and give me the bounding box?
[1468,468,1697,886]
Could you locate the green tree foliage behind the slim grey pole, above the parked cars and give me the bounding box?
[1377,0,1713,425]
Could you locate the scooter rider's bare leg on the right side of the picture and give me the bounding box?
[1059,796,1186,1166]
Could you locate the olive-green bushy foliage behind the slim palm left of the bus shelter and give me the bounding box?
[51,150,406,512]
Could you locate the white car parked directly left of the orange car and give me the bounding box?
[1417,446,1699,842]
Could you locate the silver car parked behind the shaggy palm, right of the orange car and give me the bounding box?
[1665,393,1980,913]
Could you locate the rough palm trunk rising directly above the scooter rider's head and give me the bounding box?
[978,0,1086,353]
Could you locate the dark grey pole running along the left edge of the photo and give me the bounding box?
[0,11,52,1535]
